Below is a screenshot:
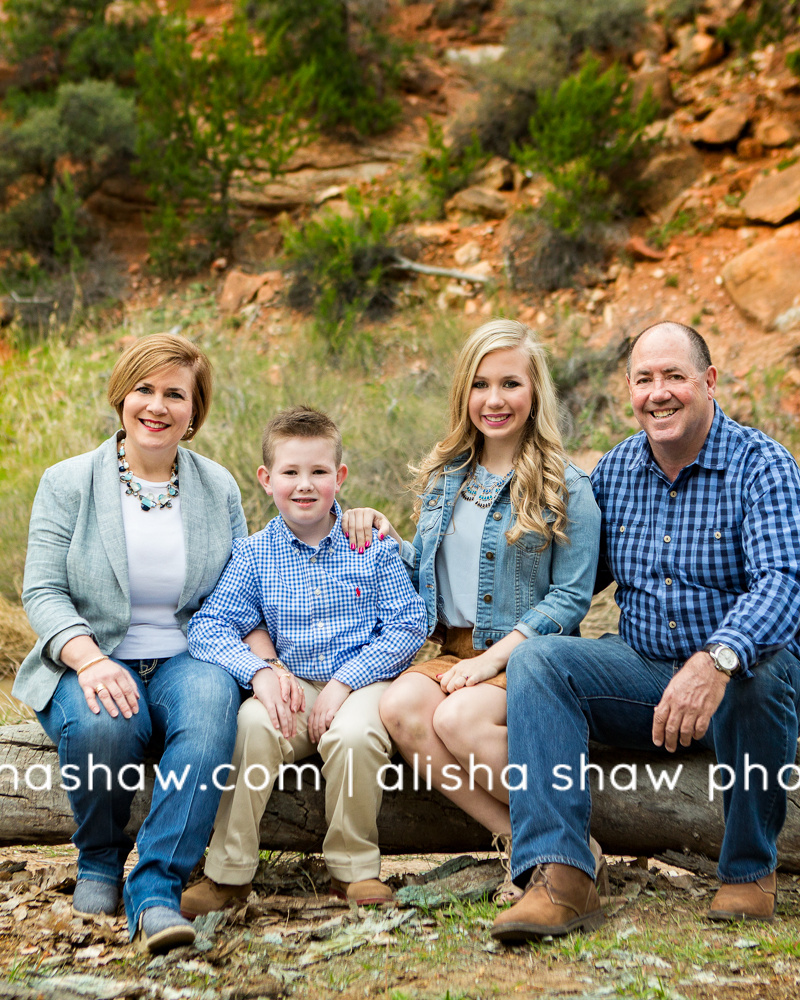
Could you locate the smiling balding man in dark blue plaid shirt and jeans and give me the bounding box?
[492,322,800,941]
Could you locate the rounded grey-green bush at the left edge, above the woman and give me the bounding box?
[0,80,136,260]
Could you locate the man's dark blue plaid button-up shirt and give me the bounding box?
[592,403,800,674]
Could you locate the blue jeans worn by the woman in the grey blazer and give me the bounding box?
[37,653,240,936]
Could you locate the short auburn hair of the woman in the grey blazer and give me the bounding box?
[108,333,213,440]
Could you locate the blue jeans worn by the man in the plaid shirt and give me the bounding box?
[507,635,800,882]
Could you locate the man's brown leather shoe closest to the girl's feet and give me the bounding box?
[491,864,605,943]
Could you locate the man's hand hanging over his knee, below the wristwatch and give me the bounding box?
[653,652,730,753]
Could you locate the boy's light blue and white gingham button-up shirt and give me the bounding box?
[188,504,427,690]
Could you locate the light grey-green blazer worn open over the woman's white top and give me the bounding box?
[13,434,247,711]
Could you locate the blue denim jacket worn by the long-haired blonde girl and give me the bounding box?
[401,459,600,649]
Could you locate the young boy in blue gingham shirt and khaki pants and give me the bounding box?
[181,406,427,917]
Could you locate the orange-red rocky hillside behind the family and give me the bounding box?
[4,0,800,453]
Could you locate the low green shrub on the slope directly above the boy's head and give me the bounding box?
[284,189,398,355]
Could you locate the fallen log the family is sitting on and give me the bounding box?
[0,724,800,873]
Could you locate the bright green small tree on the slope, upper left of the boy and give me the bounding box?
[136,19,310,271]
